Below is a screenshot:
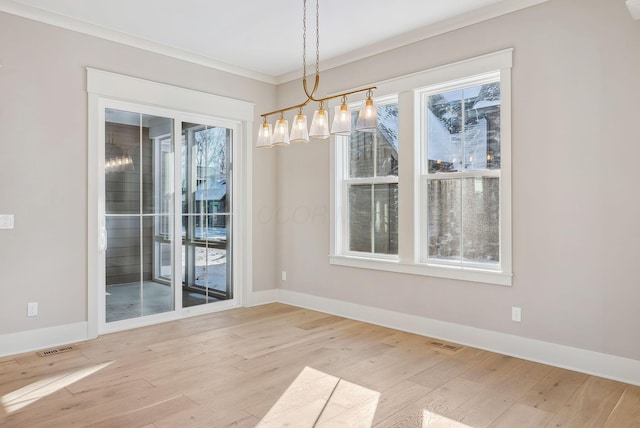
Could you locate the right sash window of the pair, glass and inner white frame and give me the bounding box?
[421,75,501,270]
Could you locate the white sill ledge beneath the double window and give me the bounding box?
[329,256,513,286]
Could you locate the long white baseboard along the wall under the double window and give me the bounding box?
[277,289,640,386]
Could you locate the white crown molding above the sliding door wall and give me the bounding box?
[0,0,277,85]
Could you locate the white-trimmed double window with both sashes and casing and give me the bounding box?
[330,49,512,285]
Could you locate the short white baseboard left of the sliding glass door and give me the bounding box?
[0,321,89,357]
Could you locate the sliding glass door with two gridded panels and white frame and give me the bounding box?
[101,102,237,331]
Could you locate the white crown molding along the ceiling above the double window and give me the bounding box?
[276,0,552,84]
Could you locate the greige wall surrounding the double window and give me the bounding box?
[277,0,640,360]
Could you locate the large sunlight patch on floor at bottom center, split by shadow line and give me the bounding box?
[257,367,380,428]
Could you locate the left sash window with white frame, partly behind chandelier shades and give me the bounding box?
[343,98,398,257]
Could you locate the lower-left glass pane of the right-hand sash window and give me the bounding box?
[427,179,462,261]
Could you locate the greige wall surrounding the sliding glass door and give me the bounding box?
[0,13,276,334]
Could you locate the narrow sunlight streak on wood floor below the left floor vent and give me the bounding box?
[0,361,113,414]
